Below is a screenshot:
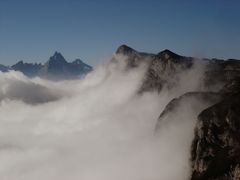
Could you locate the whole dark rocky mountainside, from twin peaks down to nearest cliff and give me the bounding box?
[116,45,240,180]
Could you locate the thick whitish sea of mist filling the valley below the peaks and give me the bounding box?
[0,55,213,180]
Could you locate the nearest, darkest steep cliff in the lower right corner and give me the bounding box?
[191,81,240,180]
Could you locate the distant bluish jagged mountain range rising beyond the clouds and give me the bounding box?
[0,52,93,80]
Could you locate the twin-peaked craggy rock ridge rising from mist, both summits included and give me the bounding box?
[115,45,198,93]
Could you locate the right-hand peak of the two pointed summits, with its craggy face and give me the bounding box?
[141,50,194,92]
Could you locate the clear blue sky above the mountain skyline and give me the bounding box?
[0,0,240,65]
